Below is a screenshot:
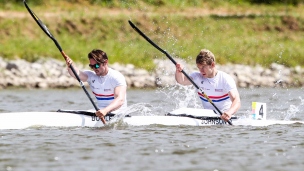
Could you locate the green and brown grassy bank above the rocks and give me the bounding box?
[0,1,304,69]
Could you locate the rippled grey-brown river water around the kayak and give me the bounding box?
[0,87,304,171]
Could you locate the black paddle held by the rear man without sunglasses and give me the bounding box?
[129,20,232,125]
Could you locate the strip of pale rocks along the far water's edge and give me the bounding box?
[0,58,304,89]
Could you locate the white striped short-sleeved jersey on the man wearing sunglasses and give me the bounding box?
[83,68,127,109]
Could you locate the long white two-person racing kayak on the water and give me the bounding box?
[0,108,304,129]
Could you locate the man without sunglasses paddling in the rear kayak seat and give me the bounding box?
[175,49,241,121]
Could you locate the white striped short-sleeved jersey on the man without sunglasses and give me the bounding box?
[190,71,237,112]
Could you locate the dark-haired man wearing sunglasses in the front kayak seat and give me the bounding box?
[66,49,127,118]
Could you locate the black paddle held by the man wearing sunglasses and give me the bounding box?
[23,0,106,124]
